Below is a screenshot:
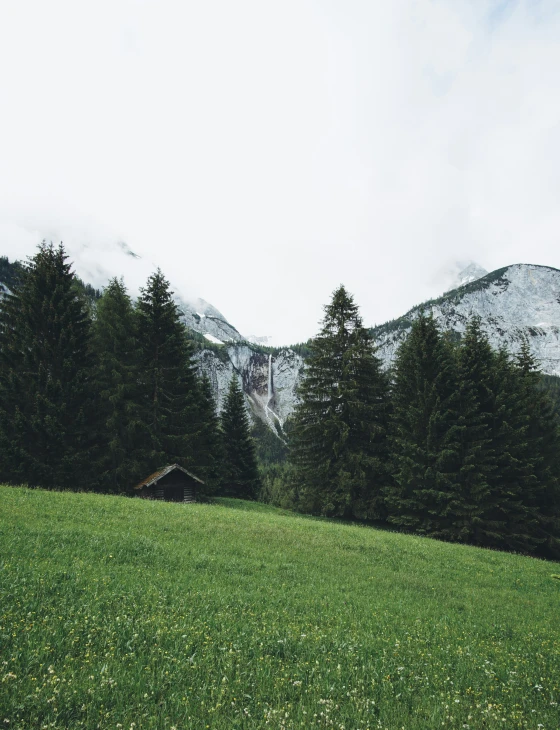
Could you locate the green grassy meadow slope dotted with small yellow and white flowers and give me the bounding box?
[0,488,560,730]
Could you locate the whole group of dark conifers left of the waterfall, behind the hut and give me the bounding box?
[0,243,259,499]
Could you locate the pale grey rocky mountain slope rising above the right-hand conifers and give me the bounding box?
[372,264,560,375]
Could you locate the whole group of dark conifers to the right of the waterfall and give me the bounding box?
[263,287,560,557]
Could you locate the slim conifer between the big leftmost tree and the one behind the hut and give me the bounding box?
[93,279,149,492]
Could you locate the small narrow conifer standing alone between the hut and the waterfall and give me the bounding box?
[221,374,260,499]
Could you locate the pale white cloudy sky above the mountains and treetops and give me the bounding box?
[0,0,560,343]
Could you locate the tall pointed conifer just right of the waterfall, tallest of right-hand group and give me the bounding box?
[290,286,388,517]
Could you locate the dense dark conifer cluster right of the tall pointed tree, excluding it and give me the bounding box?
[386,315,560,556]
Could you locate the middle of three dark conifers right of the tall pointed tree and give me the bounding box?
[453,319,535,551]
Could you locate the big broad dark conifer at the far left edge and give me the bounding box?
[0,242,96,489]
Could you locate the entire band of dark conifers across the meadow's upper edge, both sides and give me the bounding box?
[0,243,560,559]
